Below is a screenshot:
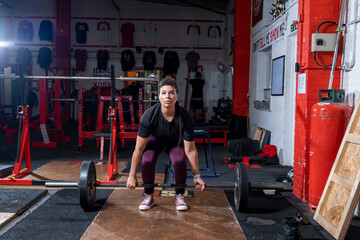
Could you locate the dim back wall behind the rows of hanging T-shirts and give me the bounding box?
[0,0,226,119]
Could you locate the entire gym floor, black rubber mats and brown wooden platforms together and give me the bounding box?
[0,124,360,239]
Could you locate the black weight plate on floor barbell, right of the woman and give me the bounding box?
[234,162,249,212]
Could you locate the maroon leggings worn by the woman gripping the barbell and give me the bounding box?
[141,136,187,194]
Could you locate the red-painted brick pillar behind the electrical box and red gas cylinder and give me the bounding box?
[293,0,341,201]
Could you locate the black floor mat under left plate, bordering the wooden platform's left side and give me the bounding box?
[0,189,112,240]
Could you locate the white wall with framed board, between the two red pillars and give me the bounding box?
[249,0,298,165]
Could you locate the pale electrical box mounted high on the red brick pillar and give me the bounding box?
[311,33,336,52]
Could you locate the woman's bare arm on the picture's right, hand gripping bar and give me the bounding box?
[184,140,205,190]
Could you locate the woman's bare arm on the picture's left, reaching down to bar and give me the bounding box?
[126,136,147,189]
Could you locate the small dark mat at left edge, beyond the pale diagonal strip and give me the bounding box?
[0,189,47,214]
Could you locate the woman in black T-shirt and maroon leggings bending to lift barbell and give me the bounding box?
[127,78,205,211]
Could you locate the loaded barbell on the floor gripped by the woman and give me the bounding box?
[0,161,292,211]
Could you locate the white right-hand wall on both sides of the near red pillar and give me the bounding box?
[249,0,360,165]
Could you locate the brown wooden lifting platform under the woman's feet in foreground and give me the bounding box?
[81,189,246,240]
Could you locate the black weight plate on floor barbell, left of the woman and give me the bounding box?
[79,161,96,211]
